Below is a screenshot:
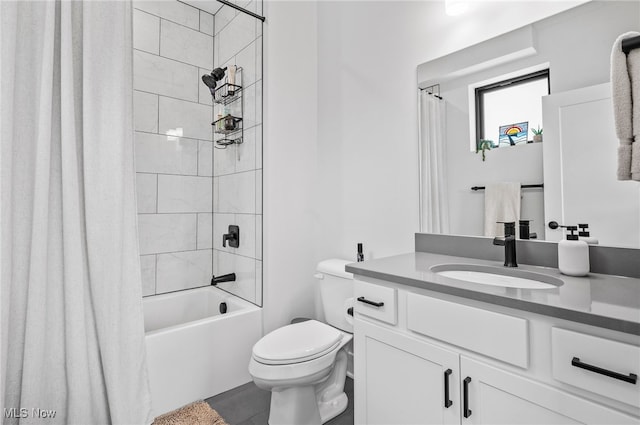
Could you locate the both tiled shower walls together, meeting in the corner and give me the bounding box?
[133,0,262,304]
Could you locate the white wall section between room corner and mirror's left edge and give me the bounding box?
[317,2,431,260]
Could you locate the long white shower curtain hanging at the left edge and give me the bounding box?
[0,1,150,424]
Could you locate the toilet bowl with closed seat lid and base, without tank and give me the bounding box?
[249,320,353,425]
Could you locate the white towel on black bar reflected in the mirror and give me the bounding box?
[484,183,520,236]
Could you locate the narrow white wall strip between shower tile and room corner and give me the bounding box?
[263,1,318,332]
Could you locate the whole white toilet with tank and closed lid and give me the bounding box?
[249,259,353,425]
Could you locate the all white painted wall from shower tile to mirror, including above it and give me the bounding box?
[264,1,596,331]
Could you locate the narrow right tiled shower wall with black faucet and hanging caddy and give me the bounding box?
[213,1,262,304]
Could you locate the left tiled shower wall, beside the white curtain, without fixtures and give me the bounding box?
[133,1,214,295]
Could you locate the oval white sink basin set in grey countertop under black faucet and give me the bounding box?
[431,264,564,289]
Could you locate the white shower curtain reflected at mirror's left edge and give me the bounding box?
[419,90,449,233]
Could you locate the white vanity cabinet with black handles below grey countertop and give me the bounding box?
[354,278,640,425]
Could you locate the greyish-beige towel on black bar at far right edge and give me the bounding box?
[611,31,640,180]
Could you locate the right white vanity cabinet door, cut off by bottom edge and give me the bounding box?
[460,356,640,425]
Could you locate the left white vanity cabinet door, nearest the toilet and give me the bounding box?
[354,319,460,425]
